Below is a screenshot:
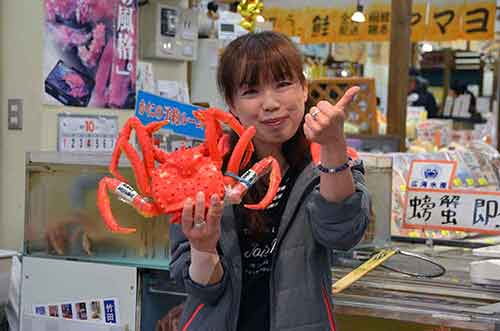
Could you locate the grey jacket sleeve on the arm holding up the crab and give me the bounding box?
[170,224,229,305]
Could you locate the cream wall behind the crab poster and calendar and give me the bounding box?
[0,0,187,249]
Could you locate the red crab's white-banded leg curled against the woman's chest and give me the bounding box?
[226,156,281,209]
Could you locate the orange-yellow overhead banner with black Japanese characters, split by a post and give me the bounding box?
[263,0,496,44]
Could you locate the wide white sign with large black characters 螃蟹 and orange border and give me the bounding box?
[403,189,500,234]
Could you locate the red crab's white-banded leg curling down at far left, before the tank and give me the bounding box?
[97,177,161,234]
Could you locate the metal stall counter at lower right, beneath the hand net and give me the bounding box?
[333,243,500,331]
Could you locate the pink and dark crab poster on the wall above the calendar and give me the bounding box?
[43,0,138,109]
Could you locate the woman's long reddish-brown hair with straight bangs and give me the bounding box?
[217,31,309,236]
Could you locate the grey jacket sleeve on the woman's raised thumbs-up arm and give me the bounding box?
[306,165,370,250]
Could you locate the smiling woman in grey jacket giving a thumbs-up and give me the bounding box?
[170,32,369,331]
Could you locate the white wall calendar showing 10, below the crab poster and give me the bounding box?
[57,114,118,153]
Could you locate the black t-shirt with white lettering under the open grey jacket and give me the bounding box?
[238,170,297,331]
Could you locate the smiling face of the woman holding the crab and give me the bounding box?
[231,80,308,145]
